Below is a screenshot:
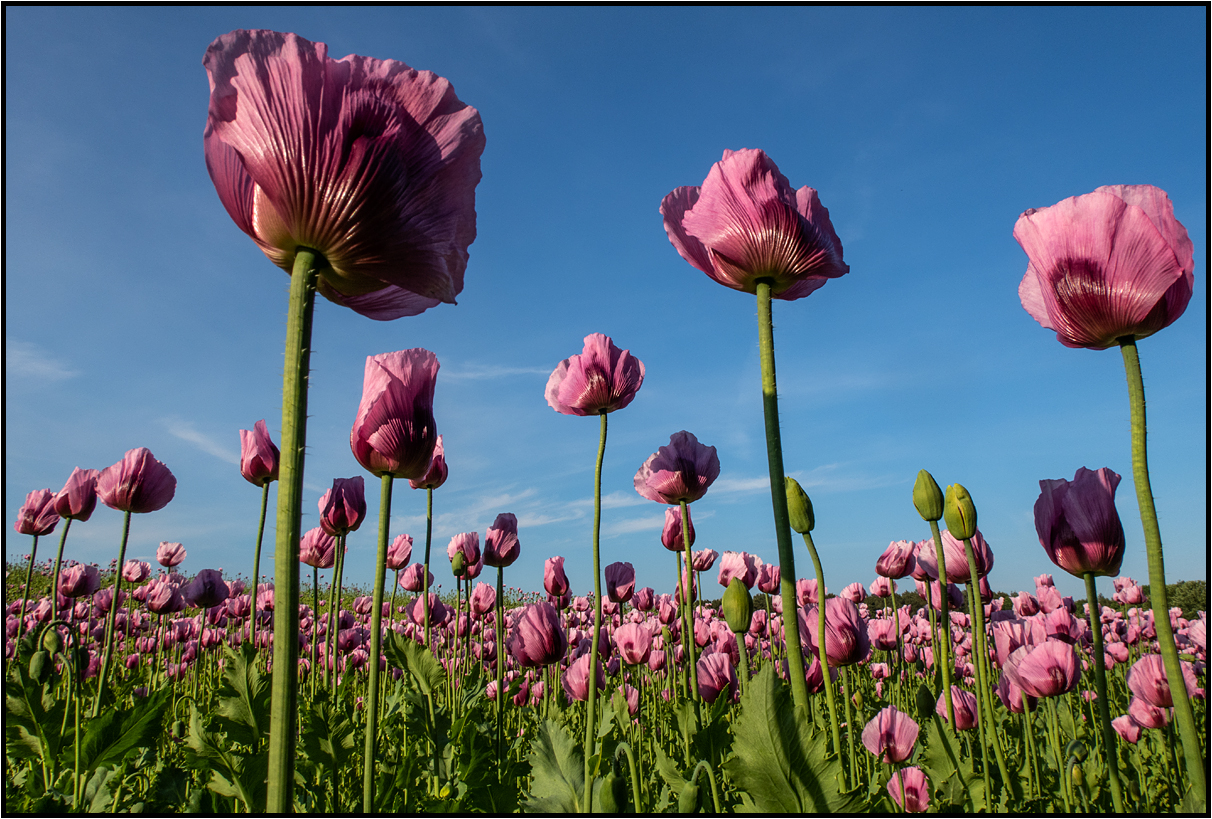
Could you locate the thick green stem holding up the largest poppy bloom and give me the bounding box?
[266,247,321,813]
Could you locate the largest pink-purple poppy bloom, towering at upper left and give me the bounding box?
[202,30,484,320]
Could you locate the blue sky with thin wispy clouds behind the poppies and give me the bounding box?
[4,7,1208,608]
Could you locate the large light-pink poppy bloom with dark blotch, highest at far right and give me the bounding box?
[1014,185,1195,350]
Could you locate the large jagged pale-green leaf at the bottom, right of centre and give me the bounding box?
[724,665,863,813]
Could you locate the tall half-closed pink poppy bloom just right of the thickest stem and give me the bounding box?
[349,349,439,479]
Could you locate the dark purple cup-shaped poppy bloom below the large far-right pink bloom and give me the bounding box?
[1035,466,1124,577]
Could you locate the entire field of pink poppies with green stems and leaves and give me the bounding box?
[4,22,1208,814]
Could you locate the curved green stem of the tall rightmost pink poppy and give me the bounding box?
[1119,336,1207,813]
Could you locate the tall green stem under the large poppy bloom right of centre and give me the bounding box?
[758,279,809,717]
